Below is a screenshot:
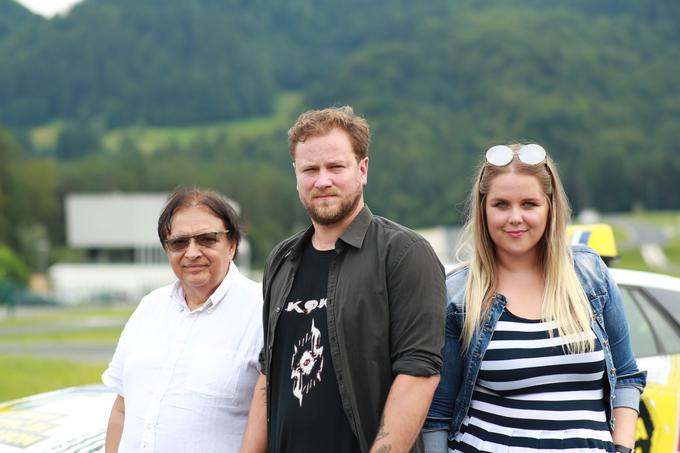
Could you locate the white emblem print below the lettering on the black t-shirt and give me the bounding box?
[290,314,323,407]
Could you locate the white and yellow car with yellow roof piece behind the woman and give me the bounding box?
[567,224,680,453]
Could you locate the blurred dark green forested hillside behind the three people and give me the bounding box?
[0,0,680,269]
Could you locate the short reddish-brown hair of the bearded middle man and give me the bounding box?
[288,105,371,162]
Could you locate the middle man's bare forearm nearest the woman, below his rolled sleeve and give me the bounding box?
[371,374,439,453]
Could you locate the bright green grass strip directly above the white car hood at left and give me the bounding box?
[0,355,106,401]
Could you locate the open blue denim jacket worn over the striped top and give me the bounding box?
[424,245,646,445]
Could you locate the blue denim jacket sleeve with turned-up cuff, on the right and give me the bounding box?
[597,252,647,410]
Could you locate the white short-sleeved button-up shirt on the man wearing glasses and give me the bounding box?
[102,263,262,453]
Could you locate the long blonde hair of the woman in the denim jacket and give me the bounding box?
[459,144,594,353]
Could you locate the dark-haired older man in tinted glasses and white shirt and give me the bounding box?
[102,188,262,453]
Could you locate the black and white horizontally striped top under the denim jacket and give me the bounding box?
[449,309,614,453]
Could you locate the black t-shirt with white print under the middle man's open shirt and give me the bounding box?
[268,241,359,453]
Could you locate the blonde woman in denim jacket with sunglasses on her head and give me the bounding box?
[424,144,645,453]
